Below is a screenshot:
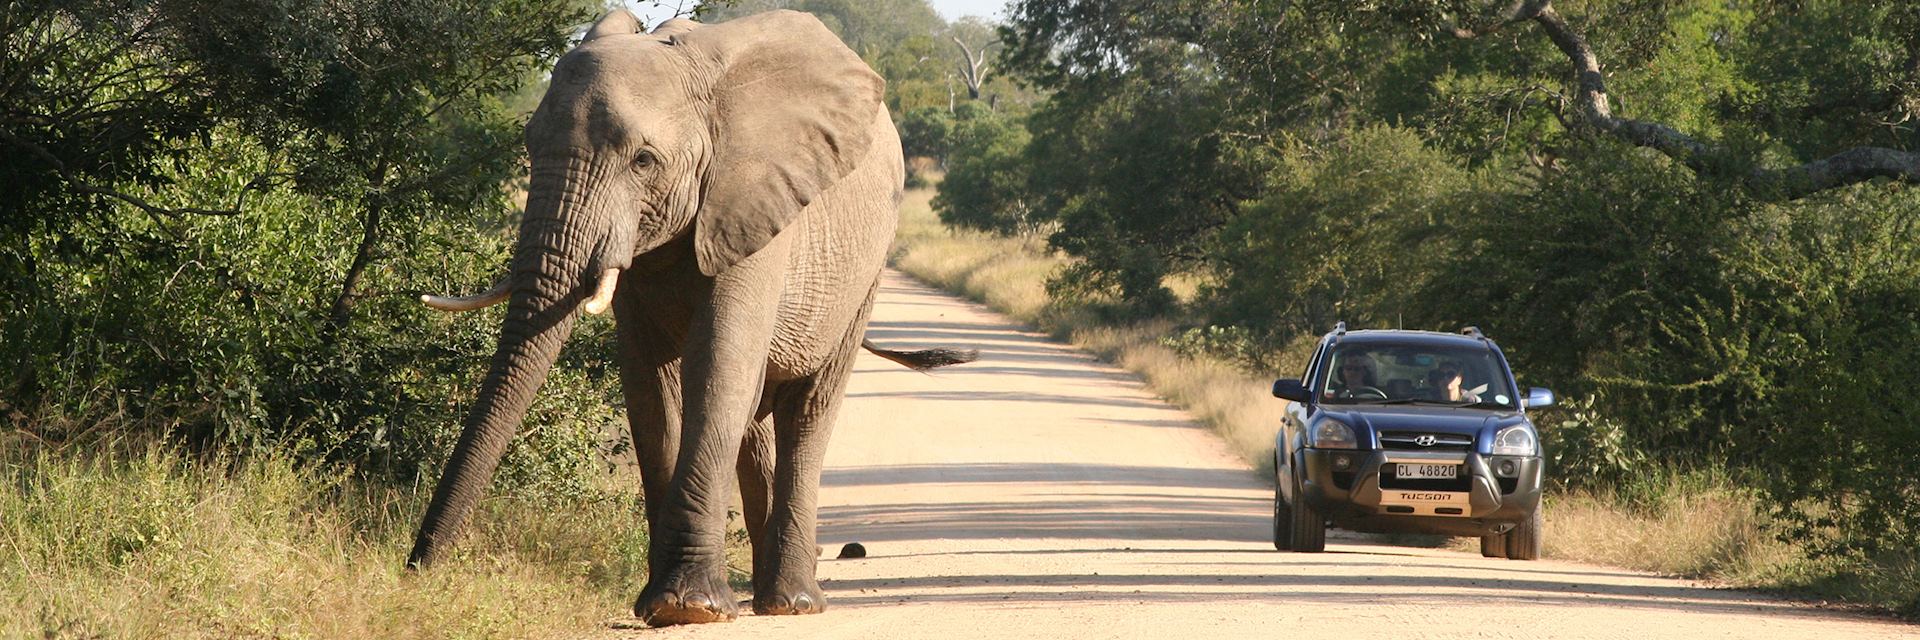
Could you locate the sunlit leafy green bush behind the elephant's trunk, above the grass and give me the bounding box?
[0,135,616,486]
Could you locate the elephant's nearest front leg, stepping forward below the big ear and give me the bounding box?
[634,240,785,627]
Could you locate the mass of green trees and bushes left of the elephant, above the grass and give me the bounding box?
[0,0,607,480]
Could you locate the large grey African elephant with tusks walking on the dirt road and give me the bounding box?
[407,10,972,625]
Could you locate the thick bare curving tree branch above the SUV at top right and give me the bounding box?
[1515,2,1920,200]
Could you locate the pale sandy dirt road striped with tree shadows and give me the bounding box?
[618,273,1920,640]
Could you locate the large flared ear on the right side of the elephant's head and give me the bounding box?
[674,12,885,275]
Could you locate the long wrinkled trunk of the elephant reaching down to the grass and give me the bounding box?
[407,175,618,567]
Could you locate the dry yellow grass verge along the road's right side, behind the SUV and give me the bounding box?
[893,183,1920,619]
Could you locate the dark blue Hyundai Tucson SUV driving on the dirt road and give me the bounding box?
[1273,323,1553,559]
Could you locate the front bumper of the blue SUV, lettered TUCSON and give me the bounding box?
[1298,448,1546,536]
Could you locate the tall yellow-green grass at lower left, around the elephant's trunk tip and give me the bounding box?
[0,442,683,638]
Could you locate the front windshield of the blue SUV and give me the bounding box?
[1315,342,1519,409]
